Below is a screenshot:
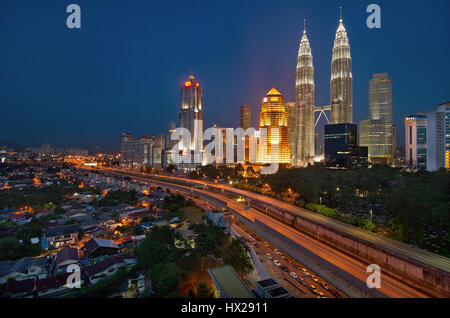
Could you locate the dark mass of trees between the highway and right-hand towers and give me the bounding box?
[234,166,450,255]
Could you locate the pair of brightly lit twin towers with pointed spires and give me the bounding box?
[289,10,353,166]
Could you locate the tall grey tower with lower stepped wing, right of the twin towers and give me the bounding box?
[359,73,395,164]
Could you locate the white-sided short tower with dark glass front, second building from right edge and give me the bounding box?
[405,114,427,169]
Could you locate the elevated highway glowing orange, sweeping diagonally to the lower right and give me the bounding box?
[82,170,450,297]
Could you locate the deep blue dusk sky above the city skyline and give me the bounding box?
[0,0,450,152]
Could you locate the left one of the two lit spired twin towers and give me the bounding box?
[290,21,315,166]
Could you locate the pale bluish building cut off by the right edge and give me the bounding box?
[426,101,450,171]
